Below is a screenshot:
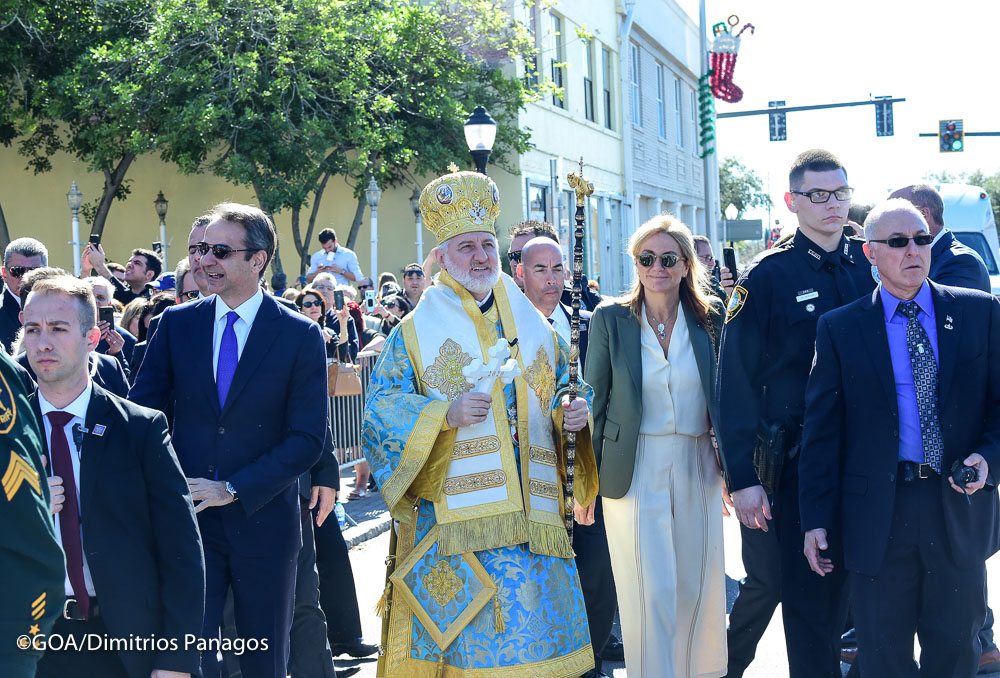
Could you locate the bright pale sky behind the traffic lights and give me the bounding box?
[680,0,1000,222]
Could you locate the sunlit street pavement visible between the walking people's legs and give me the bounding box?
[336,478,1000,678]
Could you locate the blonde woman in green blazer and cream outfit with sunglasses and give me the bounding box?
[586,216,726,678]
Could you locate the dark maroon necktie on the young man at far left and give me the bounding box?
[45,410,90,618]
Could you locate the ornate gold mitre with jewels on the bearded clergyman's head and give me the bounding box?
[420,166,500,245]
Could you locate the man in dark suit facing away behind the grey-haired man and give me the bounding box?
[889,184,990,292]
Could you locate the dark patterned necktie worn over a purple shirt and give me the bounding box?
[896,301,944,473]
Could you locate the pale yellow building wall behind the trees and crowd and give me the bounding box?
[0,148,521,279]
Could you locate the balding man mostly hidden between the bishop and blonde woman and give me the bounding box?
[517,237,618,678]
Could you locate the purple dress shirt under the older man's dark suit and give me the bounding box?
[879,280,941,464]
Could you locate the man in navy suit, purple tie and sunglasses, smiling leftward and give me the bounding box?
[129,203,327,678]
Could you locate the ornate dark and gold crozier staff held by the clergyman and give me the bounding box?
[563,157,594,542]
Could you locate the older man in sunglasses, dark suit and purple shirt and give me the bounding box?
[799,199,1000,677]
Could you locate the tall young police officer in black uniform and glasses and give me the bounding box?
[717,150,875,678]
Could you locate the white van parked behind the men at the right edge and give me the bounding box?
[935,184,1000,295]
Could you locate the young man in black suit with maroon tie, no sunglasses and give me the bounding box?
[24,276,205,678]
